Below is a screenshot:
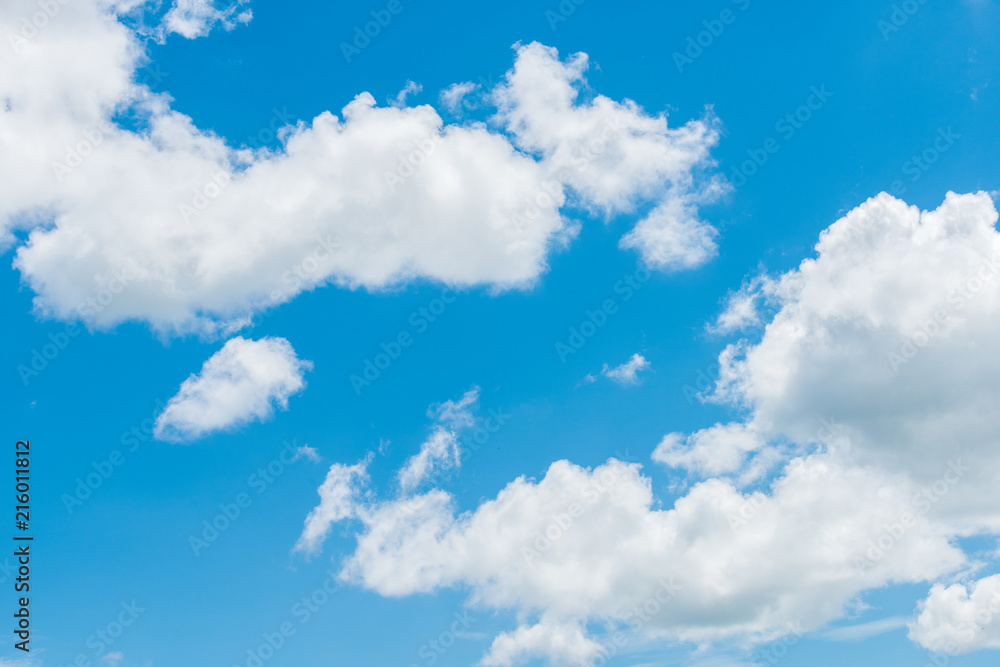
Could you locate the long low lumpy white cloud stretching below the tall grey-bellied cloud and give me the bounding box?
[302,455,965,665]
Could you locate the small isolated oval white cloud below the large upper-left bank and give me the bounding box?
[154,336,312,440]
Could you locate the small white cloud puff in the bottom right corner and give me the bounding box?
[909,574,1000,655]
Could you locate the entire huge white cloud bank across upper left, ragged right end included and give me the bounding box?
[0,0,719,333]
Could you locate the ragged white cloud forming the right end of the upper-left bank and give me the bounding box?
[494,43,727,269]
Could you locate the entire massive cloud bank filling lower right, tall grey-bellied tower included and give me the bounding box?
[296,194,1000,665]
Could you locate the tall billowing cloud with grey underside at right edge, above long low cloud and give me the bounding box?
[692,193,1000,531]
